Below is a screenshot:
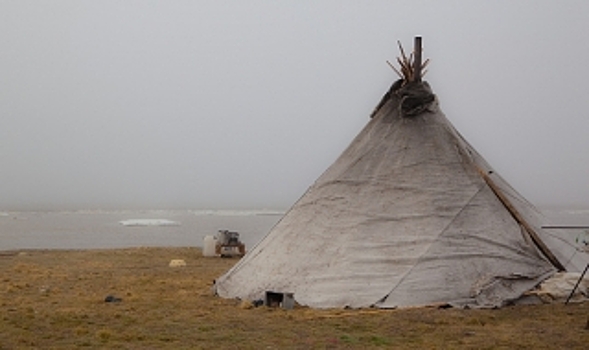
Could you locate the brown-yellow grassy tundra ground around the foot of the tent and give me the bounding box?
[0,248,589,349]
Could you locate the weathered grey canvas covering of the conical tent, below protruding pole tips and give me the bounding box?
[215,82,565,308]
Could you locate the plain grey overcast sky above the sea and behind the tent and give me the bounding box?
[0,0,589,210]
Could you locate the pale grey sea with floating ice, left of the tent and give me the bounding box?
[0,210,283,250]
